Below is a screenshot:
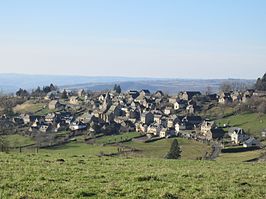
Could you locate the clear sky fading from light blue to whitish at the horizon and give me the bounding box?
[0,0,266,79]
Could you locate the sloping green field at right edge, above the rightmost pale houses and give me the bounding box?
[216,113,266,136]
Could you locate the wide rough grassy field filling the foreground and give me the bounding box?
[0,152,266,199]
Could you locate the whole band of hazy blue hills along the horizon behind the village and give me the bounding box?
[0,74,255,94]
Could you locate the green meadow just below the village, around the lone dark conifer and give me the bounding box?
[41,136,210,160]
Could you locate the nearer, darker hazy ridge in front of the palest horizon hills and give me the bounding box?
[62,79,255,94]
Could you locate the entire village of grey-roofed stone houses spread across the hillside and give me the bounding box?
[1,85,266,152]
